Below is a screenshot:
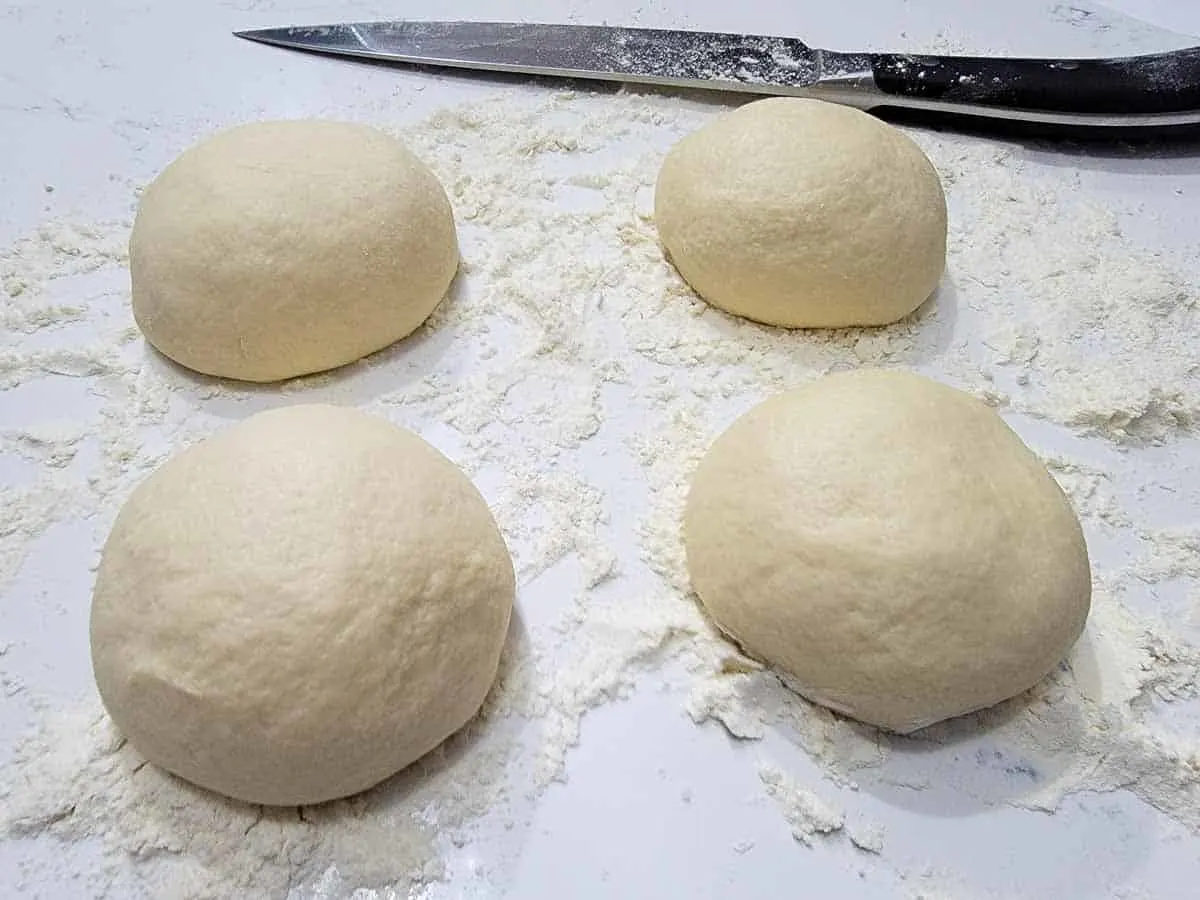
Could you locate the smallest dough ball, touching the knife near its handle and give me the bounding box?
[654,97,946,328]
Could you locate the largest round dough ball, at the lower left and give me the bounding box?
[91,406,514,805]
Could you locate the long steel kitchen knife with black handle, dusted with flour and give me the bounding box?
[234,20,1200,131]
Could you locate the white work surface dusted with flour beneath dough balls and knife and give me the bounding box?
[0,0,1200,900]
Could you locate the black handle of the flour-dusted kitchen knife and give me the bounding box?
[871,47,1200,115]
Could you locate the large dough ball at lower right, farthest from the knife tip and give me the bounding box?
[684,371,1091,733]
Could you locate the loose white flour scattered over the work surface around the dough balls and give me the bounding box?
[0,82,1200,898]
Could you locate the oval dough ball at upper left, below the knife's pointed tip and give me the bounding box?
[130,120,458,382]
